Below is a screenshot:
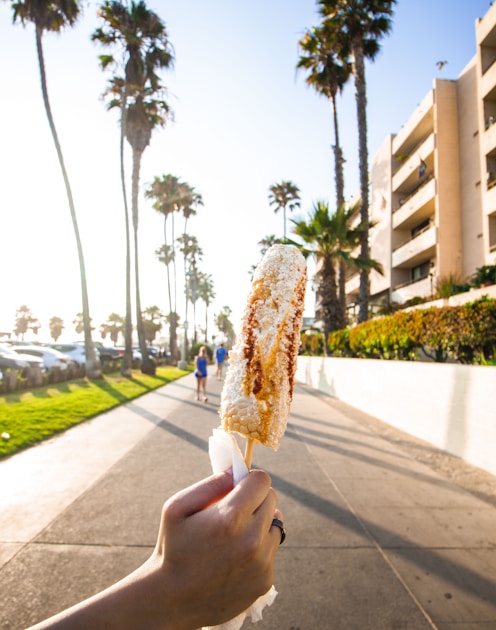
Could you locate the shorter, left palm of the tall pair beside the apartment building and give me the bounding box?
[296,26,351,208]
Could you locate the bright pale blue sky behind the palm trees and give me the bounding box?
[0,0,490,341]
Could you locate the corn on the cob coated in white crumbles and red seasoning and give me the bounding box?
[220,245,306,450]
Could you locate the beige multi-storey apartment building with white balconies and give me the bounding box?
[346,5,496,314]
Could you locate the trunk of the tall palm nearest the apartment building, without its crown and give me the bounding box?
[352,40,369,322]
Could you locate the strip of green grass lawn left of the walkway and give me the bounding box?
[0,367,187,458]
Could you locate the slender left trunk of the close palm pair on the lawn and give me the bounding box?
[120,92,133,377]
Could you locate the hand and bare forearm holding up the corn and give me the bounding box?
[29,470,282,630]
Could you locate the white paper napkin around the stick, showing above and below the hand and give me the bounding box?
[202,429,277,630]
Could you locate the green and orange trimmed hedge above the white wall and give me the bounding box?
[327,298,496,364]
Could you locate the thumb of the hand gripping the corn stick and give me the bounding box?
[164,472,233,522]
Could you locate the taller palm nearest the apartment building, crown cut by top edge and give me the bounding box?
[319,0,396,322]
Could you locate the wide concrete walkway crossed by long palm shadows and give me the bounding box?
[0,378,496,630]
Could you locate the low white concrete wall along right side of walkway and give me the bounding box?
[296,356,496,474]
